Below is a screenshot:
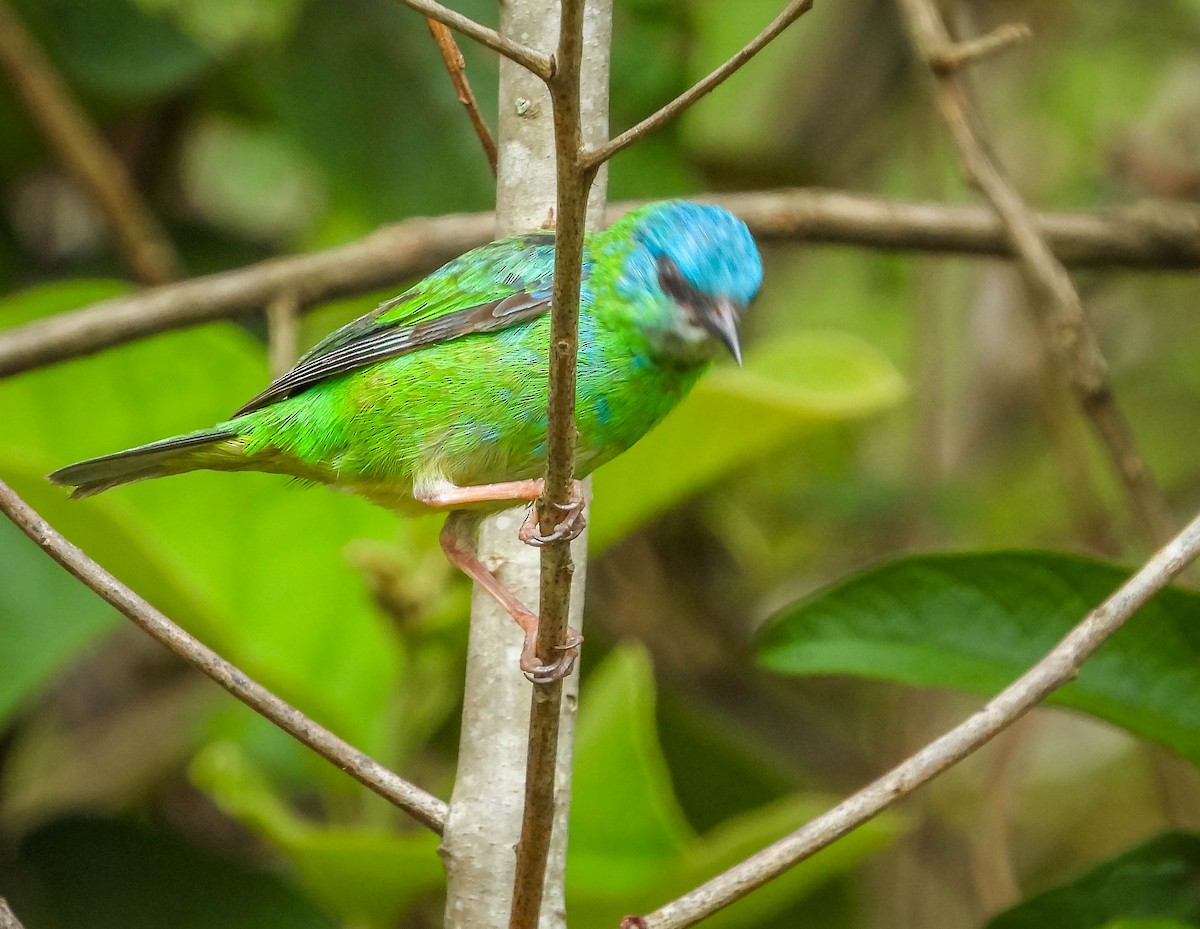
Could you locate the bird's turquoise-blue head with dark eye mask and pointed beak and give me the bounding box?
[611,200,762,364]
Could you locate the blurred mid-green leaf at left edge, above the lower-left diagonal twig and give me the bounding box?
[0,520,118,729]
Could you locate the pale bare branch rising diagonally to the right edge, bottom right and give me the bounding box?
[626,508,1200,929]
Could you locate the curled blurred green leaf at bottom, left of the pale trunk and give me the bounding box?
[191,743,444,927]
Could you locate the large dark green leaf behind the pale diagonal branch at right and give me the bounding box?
[758,552,1200,763]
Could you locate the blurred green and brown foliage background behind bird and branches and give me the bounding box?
[0,0,1200,929]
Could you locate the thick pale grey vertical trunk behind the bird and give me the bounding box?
[443,0,610,929]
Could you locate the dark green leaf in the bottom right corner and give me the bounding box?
[986,832,1200,929]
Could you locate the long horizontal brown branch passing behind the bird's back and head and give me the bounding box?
[0,188,1200,377]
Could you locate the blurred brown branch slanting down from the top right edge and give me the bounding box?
[898,0,1170,544]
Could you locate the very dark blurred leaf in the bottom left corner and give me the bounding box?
[0,820,335,929]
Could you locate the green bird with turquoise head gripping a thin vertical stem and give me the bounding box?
[49,200,763,683]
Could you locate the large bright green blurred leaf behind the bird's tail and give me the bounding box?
[0,279,398,750]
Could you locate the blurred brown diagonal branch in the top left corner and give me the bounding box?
[0,0,180,284]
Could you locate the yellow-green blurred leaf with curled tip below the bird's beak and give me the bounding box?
[590,332,905,549]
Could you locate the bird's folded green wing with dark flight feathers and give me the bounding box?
[234,234,554,416]
